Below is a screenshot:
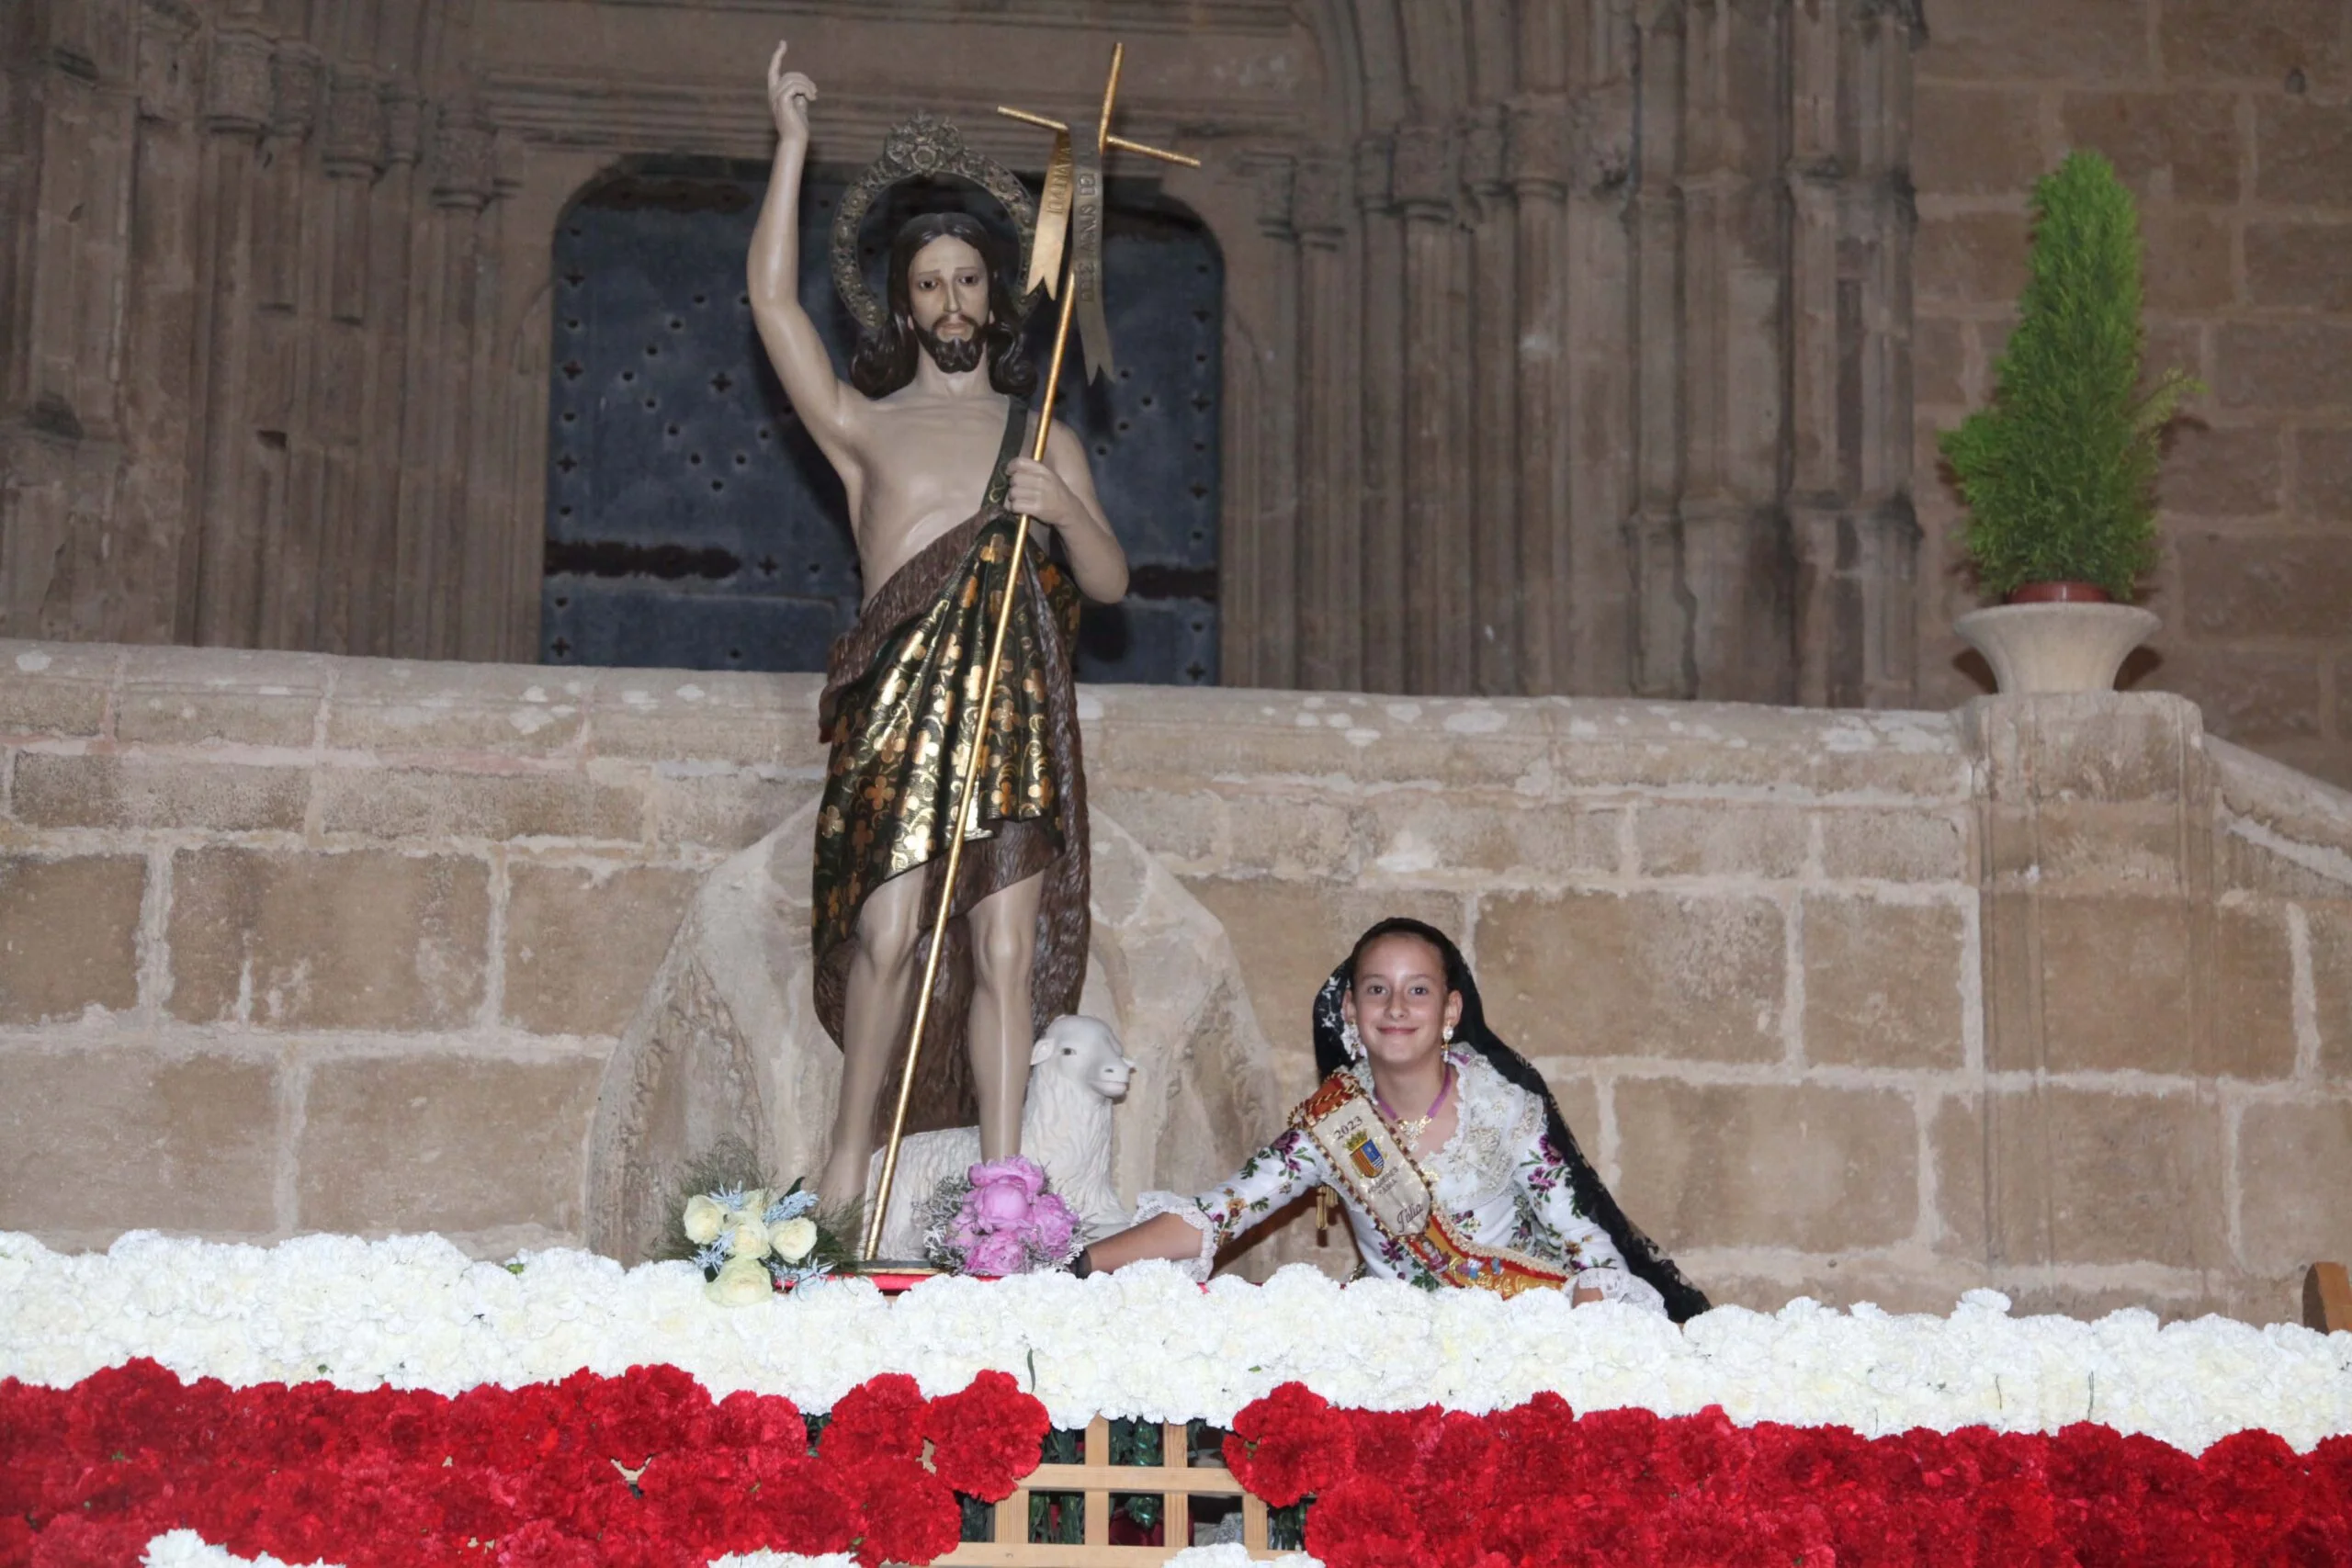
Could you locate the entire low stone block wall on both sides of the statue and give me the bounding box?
[0,642,2352,1319]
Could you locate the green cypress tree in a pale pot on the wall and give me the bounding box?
[1940,151,2201,694]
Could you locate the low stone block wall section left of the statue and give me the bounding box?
[0,644,795,1253]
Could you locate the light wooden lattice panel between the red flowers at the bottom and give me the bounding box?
[938,1417,1275,1568]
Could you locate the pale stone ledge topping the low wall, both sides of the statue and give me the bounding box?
[0,639,1969,804]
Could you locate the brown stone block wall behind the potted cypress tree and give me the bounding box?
[1912,0,2352,783]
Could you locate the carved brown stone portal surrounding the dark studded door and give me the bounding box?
[0,0,1927,705]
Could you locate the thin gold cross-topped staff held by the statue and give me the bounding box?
[864,45,1200,1258]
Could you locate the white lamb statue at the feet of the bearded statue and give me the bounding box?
[865,1013,1136,1258]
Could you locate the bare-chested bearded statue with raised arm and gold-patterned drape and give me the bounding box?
[751,45,1126,1203]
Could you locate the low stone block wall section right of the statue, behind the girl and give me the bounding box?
[1089,691,2352,1321]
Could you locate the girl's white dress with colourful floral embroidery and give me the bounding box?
[1136,1048,1665,1314]
